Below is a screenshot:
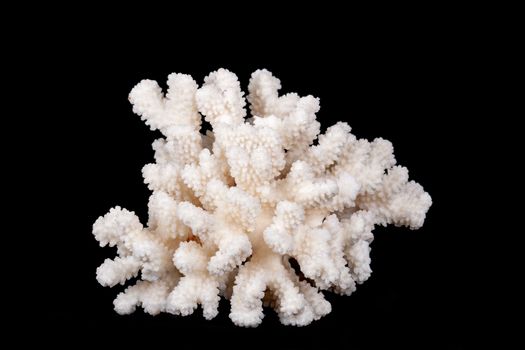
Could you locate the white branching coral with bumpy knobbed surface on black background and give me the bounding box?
[93,69,431,326]
